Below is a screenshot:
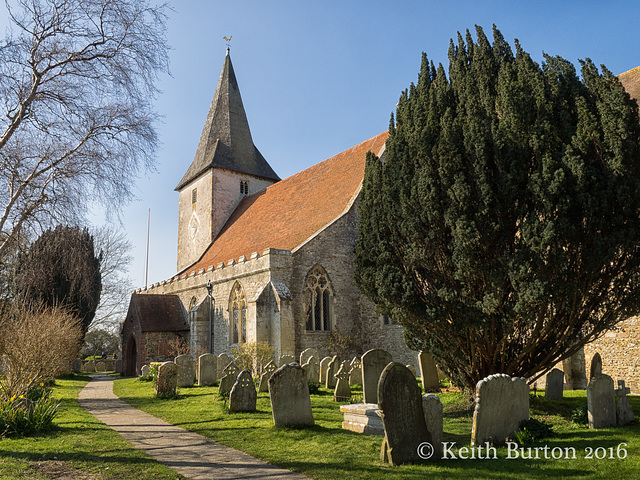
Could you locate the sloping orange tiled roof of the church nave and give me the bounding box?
[181,132,388,274]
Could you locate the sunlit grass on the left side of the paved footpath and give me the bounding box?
[0,375,184,480]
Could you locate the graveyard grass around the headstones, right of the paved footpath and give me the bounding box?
[114,379,640,480]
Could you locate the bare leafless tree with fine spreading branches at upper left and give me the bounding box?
[0,0,168,258]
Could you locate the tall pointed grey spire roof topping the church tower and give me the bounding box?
[176,48,280,190]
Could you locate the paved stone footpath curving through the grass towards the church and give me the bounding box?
[78,374,308,480]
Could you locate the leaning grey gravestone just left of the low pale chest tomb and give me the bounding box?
[269,363,315,427]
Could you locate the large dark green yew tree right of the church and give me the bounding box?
[355,27,640,388]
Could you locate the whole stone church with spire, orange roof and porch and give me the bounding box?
[122,49,417,374]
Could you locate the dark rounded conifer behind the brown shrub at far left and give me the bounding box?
[16,226,102,333]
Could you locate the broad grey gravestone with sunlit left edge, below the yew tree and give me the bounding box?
[471,373,529,446]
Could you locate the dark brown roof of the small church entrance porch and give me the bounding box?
[127,293,189,332]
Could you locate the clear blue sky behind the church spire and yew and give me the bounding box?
[5,0,640,286]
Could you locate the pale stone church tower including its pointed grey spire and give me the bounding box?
[175,48,280,272]
